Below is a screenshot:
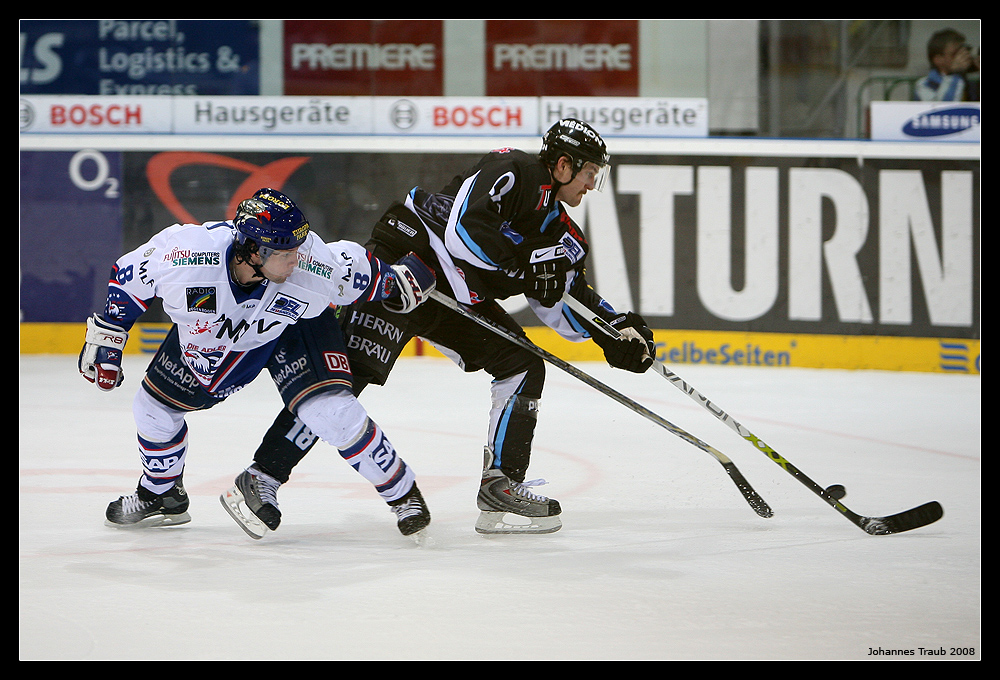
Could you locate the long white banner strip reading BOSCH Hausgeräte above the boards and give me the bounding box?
[19,95,708,138]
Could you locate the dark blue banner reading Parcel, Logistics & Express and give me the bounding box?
[20,19,260,96]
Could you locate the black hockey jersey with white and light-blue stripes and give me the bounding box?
[372,148,616,341]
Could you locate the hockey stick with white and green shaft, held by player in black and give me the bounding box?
[563,295,944,536]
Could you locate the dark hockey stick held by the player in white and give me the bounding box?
[430,290,774,517]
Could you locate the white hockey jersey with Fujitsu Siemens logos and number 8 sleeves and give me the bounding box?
[104,222,394,392]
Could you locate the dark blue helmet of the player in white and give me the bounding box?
[233,189,309,253]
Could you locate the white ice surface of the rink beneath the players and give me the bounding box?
[18,355,982,660]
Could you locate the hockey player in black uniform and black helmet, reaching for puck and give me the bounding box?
[238,119,654,533]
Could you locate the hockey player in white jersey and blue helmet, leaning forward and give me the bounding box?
[79,189,435,538]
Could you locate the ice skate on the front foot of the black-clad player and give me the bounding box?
[476,469,562,534]
